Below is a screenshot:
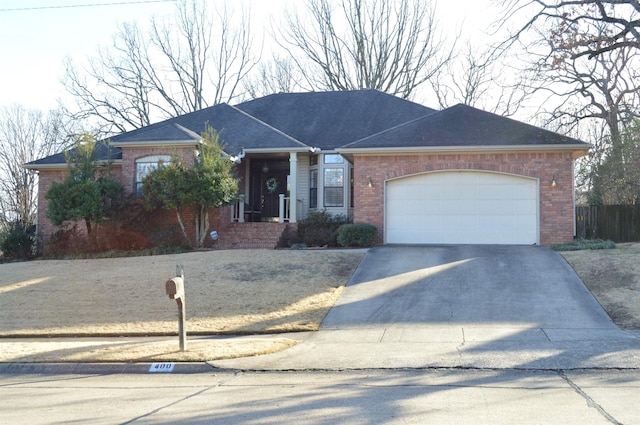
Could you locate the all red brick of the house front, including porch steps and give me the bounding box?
[38,146,574,247]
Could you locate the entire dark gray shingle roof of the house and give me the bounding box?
[27,90,589,168]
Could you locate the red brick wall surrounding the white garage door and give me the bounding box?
[354,152,574,245]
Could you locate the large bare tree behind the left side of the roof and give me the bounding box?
[64,0,257,133]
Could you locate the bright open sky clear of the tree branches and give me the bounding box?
[0,0,493,110]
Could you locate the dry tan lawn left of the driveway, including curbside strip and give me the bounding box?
[0,250,364,361]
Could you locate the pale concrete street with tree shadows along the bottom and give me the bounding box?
[0,365,640,425]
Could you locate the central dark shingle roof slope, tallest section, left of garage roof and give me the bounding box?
[237,90,436,150]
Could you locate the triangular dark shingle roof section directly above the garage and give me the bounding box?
[344,104,589,149]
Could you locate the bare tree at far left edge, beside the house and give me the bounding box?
[0,104,69,227]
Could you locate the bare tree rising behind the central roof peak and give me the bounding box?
[276,0,451,98]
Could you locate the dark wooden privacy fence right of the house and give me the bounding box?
[576,205,640,242]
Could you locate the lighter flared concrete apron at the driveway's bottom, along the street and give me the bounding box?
[210,326,640,370]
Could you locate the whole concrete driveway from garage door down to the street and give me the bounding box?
[213,245,640,370]
